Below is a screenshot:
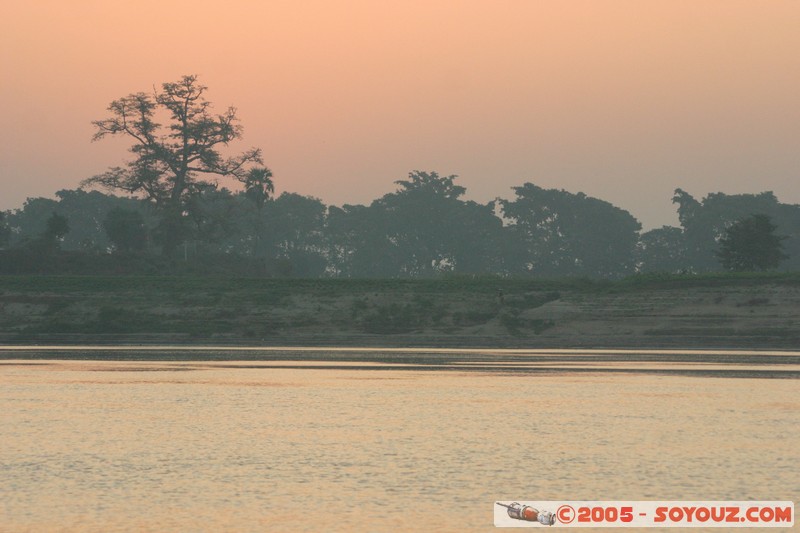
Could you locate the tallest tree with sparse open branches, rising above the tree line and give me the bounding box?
[82,75,271,254]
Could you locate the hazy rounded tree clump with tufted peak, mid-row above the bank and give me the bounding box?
[329,171,502,277]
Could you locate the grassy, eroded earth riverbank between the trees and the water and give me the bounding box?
[0,274,800,349]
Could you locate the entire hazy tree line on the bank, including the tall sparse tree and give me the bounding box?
[0,76,800,278]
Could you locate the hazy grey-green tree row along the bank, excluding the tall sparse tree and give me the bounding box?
[0,179,800,279]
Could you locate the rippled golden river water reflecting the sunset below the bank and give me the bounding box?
[0,351,800,532]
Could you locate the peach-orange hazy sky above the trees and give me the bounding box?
[0,0,800,229]
